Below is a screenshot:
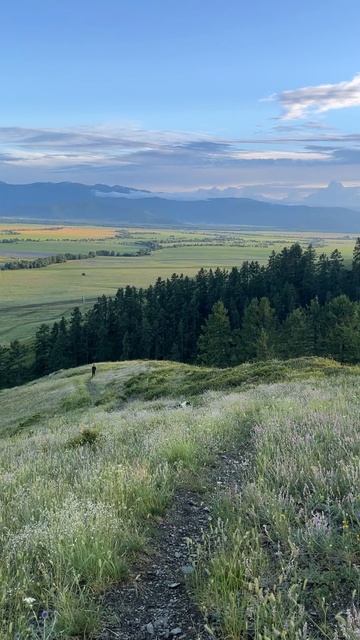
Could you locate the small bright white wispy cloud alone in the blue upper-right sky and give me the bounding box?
[268,73,360,120]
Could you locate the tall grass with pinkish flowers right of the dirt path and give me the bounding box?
[196,378,360,640]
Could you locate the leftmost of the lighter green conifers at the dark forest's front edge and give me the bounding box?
[198,301,232,367]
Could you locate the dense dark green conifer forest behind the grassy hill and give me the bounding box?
[0,238,360,388]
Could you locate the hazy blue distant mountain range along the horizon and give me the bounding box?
[0,182,360,233]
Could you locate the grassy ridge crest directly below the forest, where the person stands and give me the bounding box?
[0,358,354,436]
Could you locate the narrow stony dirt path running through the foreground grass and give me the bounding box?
[99,453,245,640]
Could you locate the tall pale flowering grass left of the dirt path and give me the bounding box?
[0,380,253,640]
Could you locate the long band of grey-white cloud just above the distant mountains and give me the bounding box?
[0,121,360,191]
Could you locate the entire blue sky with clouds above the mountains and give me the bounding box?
[0,0,360,199]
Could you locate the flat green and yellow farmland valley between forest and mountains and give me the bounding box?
[0,223,355,344]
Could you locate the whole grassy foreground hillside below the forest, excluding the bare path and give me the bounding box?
[0,359,360,640]
